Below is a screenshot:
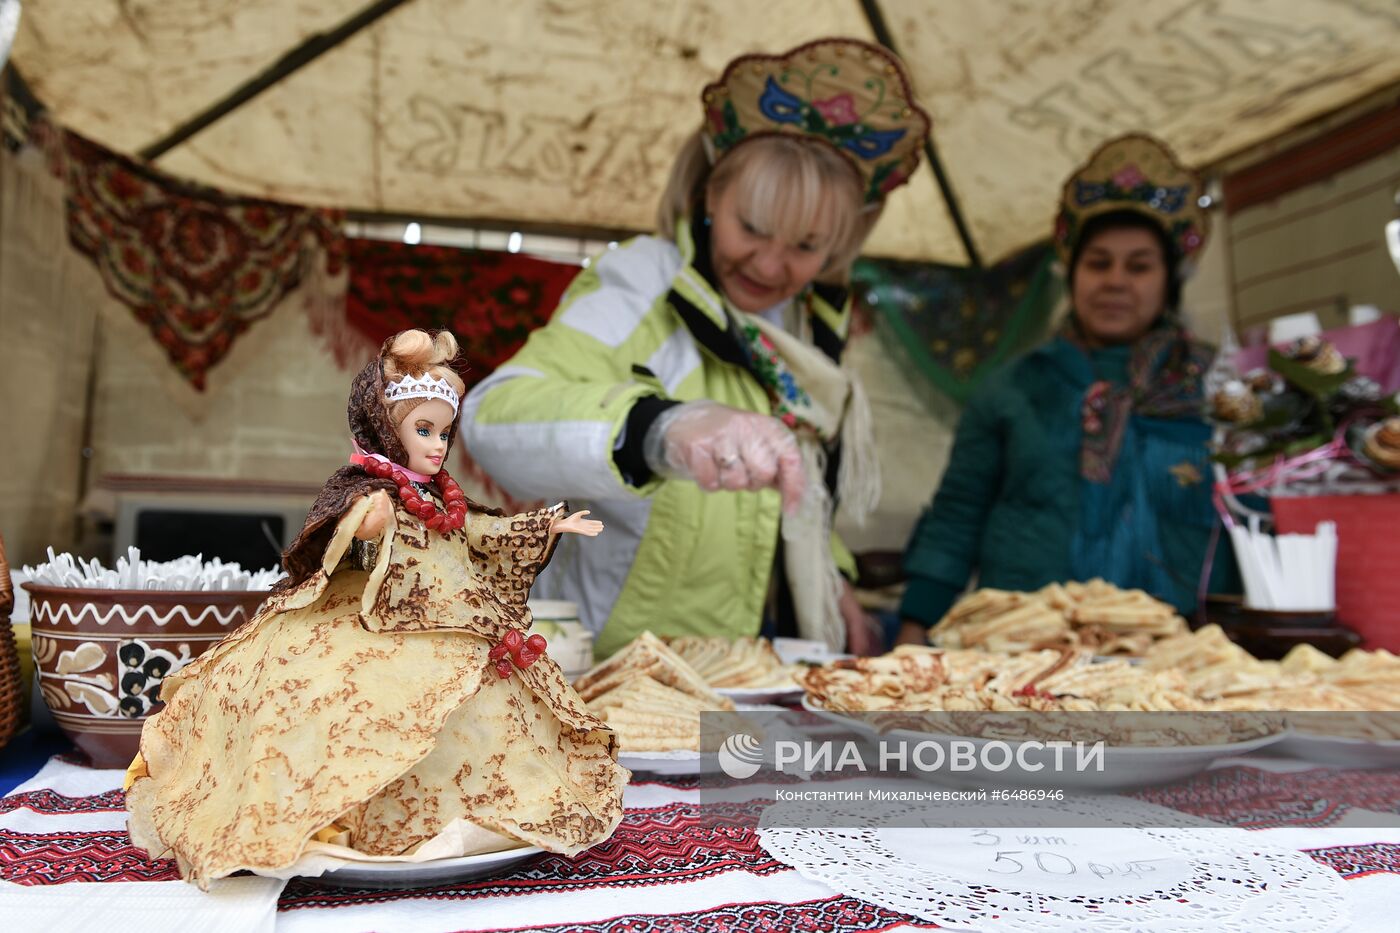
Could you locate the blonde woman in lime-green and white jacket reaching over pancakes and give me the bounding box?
[462,39,928,654]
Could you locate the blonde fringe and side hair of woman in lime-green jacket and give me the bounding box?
[657,130,881,284]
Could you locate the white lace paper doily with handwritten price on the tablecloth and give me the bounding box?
[759,797,1351,933]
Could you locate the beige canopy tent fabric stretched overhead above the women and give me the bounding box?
[13,0,1400,265]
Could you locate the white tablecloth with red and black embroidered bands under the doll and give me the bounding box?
[0,756,1400,933]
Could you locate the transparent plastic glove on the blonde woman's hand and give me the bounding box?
[641,401,806,511]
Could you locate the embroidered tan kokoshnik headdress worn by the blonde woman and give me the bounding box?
[701,39,930,205]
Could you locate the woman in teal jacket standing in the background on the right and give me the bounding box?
[899,134,1228,643]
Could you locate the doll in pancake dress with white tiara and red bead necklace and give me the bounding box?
[127,331,629,887]
